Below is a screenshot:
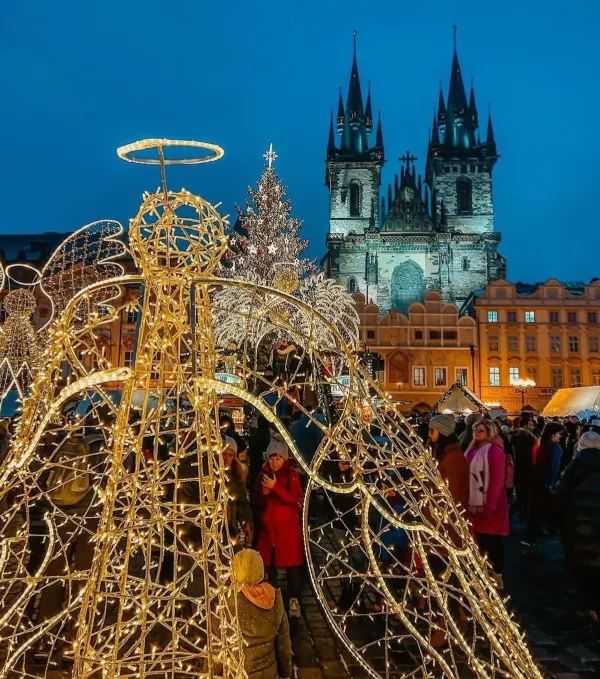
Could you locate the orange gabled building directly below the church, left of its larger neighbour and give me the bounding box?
[354,290,478,412]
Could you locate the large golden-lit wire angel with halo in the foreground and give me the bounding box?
[0,140,541,679]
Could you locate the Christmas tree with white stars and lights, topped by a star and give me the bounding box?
[229,144,316,292]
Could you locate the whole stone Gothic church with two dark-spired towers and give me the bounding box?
[323,36,506,313]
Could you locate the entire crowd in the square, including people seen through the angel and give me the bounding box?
[0,408,600,679]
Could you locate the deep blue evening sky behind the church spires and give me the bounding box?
[0,0,600,281]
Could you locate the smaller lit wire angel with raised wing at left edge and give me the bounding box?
[0,220,125,409]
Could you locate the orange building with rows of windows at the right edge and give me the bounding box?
[471,279,600,413]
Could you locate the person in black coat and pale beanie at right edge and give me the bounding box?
[555,431,600,622]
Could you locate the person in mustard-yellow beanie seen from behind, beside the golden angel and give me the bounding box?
[232,549,292,679]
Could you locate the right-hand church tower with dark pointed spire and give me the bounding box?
[426,28,498,234]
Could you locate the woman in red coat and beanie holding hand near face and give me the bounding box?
[254,441,304,618]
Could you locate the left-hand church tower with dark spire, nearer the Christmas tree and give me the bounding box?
[325,32,384,240]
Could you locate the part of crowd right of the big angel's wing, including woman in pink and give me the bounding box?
[419,412,600,622]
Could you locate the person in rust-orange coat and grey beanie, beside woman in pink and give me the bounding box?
[429,415,469,509]
